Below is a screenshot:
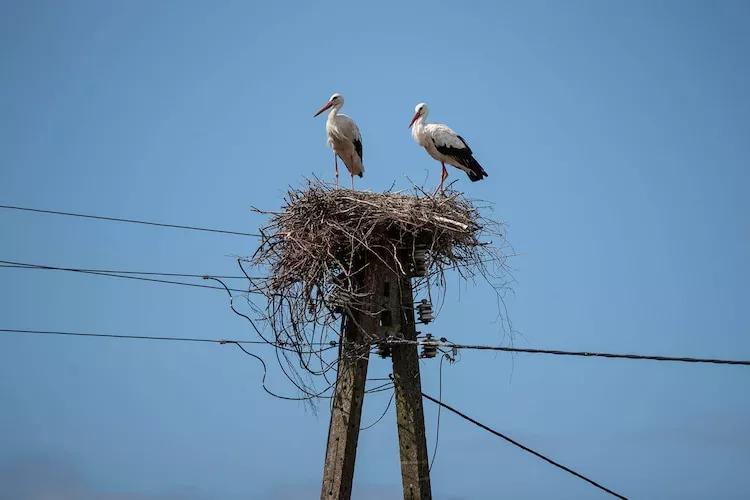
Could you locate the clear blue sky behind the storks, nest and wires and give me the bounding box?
[0,0,750,500]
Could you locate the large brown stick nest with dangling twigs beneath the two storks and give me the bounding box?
[249,180,509,394]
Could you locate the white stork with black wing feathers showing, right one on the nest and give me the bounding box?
[409,103,487,196]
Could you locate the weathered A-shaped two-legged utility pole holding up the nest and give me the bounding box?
[320,250,432,500]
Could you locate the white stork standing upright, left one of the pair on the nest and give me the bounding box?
[313,94,365,189]
